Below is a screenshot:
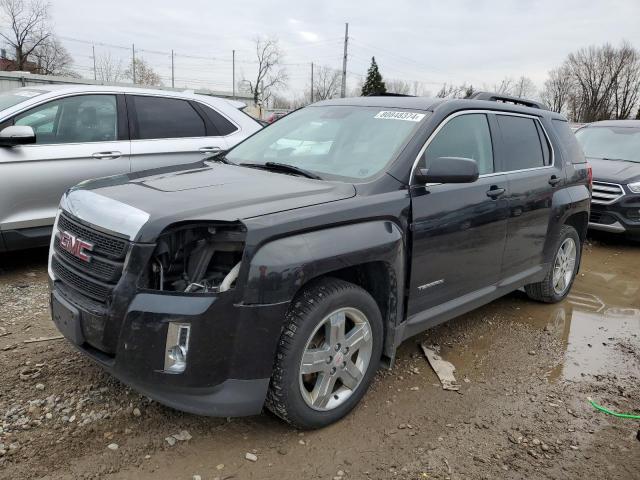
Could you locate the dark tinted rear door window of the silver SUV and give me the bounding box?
[131,95,206,140]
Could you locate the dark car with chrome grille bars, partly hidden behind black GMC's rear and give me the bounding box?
[576,120,640,240]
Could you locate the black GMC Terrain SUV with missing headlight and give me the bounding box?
[49,94,591,428]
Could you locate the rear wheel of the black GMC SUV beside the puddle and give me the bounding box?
[524,225,582,303]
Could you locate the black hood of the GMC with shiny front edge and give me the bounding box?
[61,162,356,242]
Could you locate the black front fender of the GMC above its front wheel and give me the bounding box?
[242,220,405,358]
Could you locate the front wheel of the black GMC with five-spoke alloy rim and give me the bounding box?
[266,278,383,429]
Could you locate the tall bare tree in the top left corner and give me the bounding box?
[0,0,51,70]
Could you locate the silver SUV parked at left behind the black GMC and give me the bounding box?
[0,85,262,252]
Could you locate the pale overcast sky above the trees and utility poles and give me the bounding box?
[43,0,640,97]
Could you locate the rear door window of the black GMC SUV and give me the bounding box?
[496,115,549,171]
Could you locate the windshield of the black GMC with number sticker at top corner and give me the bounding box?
[227,106,427,181]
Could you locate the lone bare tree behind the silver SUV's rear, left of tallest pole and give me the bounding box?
[244,37,287,105]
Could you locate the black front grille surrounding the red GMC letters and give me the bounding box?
[51,214,129,304]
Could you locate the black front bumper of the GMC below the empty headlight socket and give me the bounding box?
[51,282,288,417]
